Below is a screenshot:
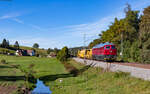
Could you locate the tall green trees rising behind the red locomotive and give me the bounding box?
[88,4,150,63]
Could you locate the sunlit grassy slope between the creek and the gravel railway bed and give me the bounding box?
[46,61,150,94]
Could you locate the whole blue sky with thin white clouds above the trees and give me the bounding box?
[0,0,150,49]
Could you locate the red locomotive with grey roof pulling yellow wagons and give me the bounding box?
[77,42,117,61]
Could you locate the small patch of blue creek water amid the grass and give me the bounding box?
[31,79,52,94]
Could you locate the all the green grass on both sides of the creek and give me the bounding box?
[0,55,150,94]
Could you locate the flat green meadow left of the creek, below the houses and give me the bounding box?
[0,55,67,94]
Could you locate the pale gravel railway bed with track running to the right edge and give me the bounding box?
[73,58,150,81]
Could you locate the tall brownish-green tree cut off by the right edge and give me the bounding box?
[139,6,150,63]
